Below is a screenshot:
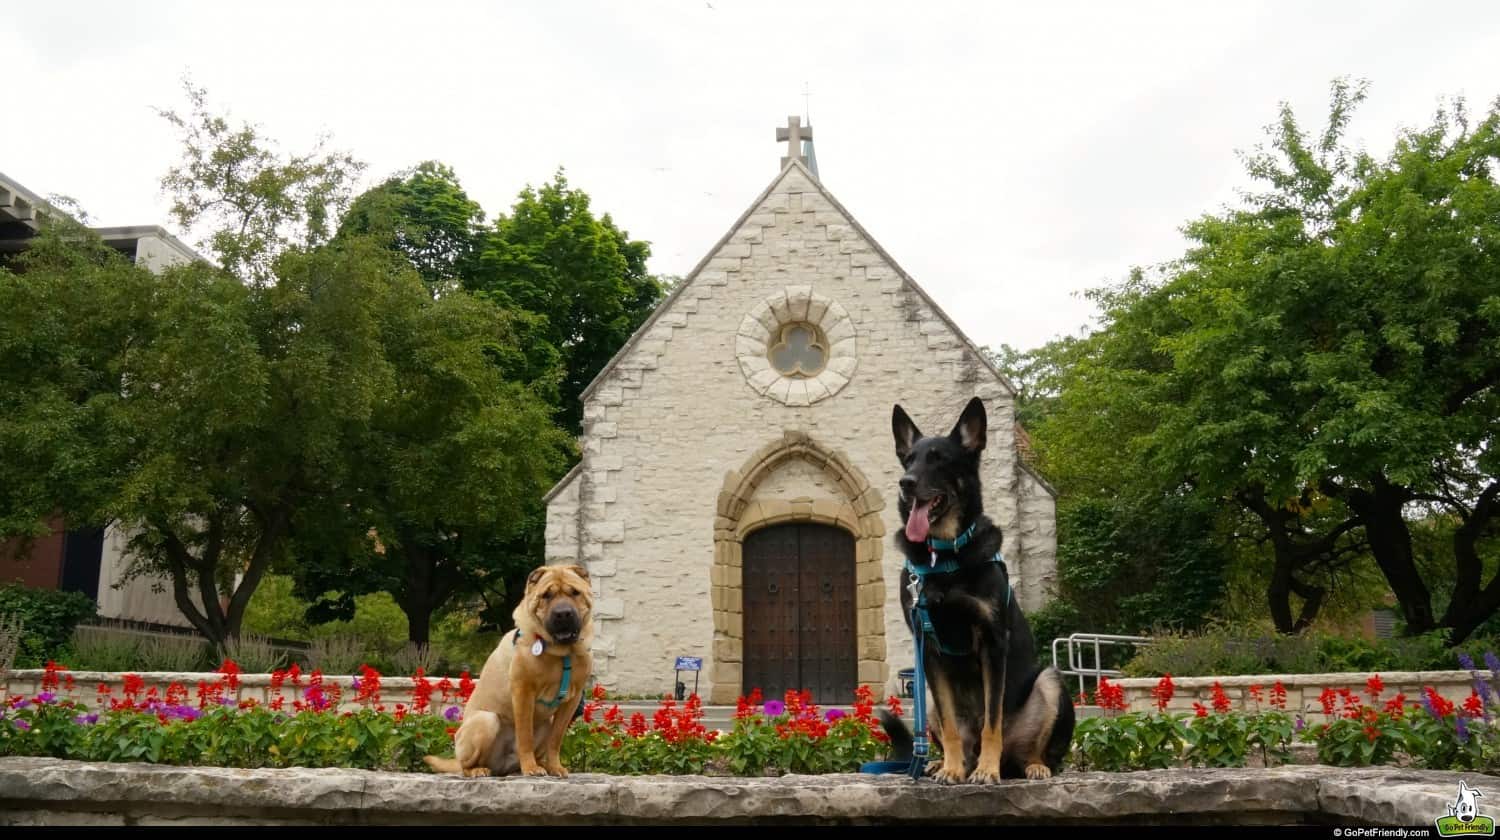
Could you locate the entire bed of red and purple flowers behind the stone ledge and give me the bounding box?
[11,656,1500,776]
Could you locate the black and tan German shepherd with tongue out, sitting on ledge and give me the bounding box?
[884,398,1074,785]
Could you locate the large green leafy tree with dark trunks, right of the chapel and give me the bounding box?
[1040,83,1500,639]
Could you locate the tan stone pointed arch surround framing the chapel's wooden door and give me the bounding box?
[708,431,887,704]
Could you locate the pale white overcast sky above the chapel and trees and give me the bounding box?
[0,0,1500,347]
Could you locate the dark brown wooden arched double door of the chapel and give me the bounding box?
[743,522,860,705]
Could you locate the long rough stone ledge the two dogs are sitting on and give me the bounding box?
[0,758,1482,825]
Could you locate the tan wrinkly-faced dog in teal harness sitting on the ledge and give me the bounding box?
[423,566,594,777]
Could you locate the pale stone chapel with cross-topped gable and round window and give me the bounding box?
[546,117,1056,704]
